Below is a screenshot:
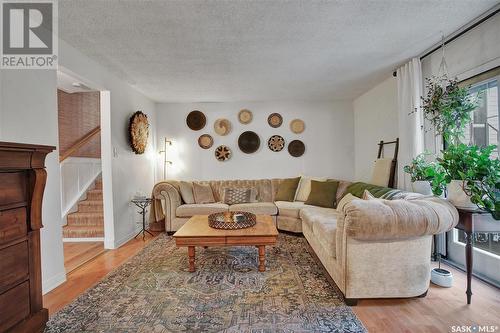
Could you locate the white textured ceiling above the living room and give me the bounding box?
[59,0,498,102]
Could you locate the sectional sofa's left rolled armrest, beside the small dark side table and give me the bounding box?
[149,181,182,231]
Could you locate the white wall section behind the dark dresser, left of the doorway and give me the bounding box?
[0,70,66,292]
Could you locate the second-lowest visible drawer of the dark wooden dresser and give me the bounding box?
[0,241,29,292]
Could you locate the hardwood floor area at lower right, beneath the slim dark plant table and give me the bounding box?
[352,265,500,333]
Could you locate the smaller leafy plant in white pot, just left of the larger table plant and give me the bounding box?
[403,152,443,195]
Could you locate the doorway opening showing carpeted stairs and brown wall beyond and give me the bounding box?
[57,71,112,273]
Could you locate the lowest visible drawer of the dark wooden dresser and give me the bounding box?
[0,281,30,332]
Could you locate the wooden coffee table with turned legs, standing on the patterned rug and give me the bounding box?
[174,215,278,272]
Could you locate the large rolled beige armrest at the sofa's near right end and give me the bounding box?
[342,197,458,241]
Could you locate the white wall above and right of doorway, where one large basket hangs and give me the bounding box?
[59,41,157,248]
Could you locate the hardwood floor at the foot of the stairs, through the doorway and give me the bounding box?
[63,242,105,273]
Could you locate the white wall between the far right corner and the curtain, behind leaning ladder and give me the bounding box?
[353,76,399,181]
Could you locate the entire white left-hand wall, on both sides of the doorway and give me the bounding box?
[0,41,156,293]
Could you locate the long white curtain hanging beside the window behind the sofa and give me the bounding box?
[397,58,424,191]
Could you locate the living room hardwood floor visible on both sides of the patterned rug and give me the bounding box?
[43,232,500,333]
